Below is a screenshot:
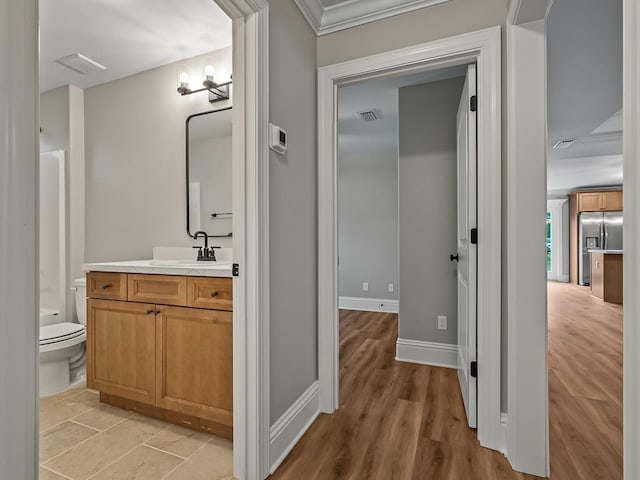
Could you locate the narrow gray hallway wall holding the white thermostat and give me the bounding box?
[269,0,318,424]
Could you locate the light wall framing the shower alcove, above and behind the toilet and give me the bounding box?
[40,85,85,320]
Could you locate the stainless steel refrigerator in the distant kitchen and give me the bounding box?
[578,212,623,285]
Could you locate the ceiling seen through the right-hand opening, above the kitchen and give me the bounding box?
[547,0,622,192]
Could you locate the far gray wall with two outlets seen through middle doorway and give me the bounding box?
[338,150,398,300]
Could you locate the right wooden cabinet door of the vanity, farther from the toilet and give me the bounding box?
[156,306,233,438]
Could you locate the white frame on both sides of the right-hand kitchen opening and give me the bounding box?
[506,0,640,480]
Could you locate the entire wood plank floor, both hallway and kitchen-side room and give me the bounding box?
[270,283,622,480]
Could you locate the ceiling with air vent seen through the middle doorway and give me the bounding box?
[338,65,467,155]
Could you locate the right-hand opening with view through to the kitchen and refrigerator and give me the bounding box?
[546,0,626,480]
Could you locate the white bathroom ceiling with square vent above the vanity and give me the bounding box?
[40,0,232,92]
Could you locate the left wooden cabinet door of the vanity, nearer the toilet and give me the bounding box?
[87,298,156,404]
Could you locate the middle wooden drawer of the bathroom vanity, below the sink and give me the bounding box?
[128,274,187,306]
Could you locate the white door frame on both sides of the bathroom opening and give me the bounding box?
[0,0,269,480]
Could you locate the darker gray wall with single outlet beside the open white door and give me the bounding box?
[398,78,464,344]
